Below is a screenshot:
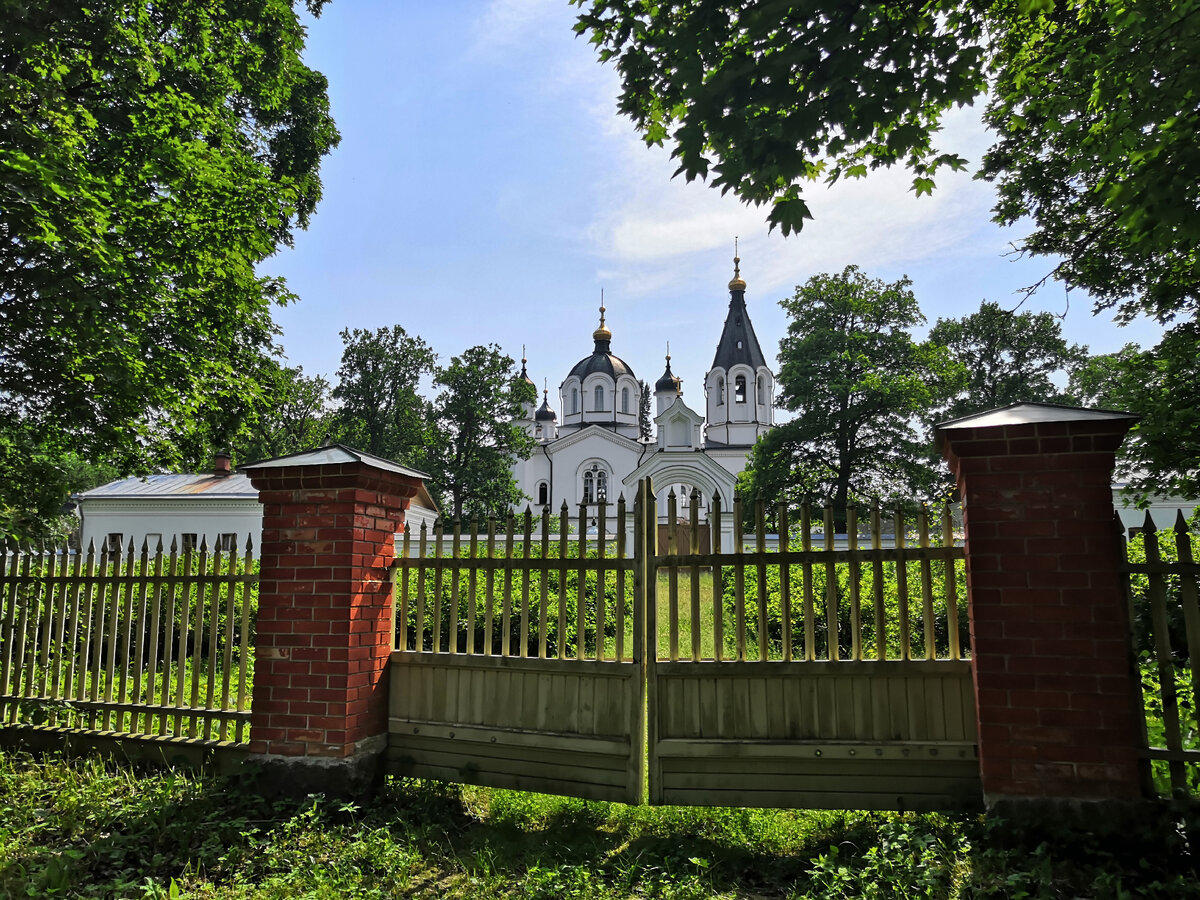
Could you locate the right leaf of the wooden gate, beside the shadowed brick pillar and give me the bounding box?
[646,482,982,810]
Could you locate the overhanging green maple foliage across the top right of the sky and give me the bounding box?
[572,0,1200,319]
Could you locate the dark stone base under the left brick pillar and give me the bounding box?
[244,734,388,800]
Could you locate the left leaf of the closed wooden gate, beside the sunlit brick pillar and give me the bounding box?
[388,489,646,803]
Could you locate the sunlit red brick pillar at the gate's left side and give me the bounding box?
[245,445,422,794]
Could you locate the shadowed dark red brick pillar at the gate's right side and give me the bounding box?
[938,403,1141,806]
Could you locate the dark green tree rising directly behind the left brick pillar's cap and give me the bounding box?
[334,325,437,464]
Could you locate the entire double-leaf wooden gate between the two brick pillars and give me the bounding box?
[389,480,982,810]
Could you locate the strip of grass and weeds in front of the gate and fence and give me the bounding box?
[0,752,1200,900]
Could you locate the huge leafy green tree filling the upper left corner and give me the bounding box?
[0,0,338,470]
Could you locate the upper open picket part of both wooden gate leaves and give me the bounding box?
[395,492,968,661]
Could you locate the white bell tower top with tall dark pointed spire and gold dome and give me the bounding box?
[704,257,775,446]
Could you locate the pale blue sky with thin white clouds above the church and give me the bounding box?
[262,0,1159,412]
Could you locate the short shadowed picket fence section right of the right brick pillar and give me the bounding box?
[1117,511,1200,797]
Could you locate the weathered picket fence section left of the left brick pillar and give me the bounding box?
[0,541,258,743]
